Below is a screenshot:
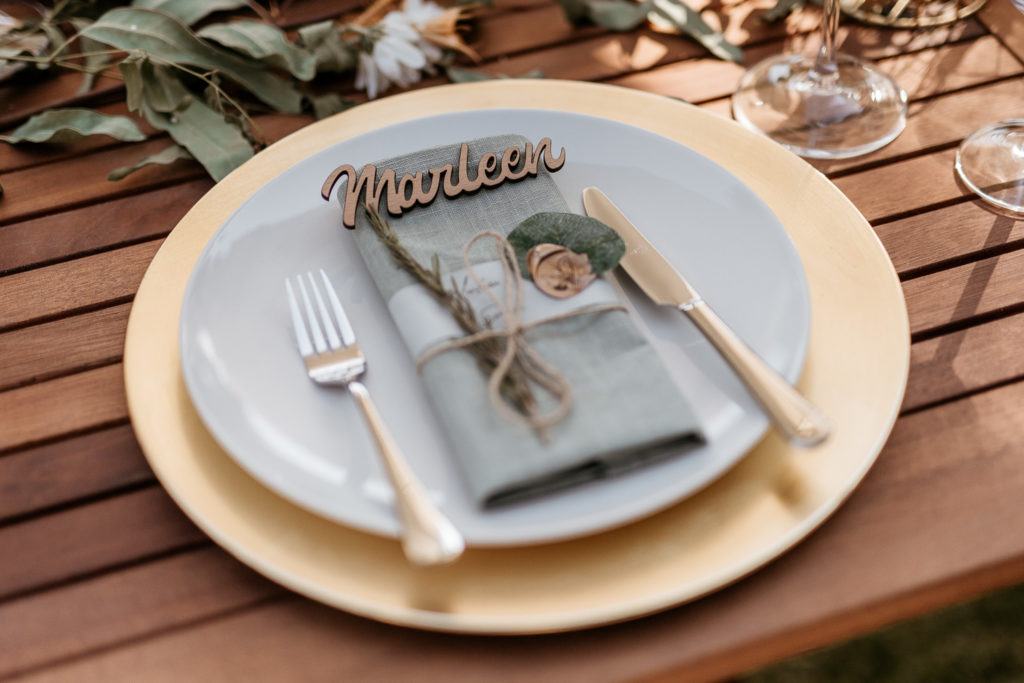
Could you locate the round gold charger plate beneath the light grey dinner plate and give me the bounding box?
[124,81,909,634]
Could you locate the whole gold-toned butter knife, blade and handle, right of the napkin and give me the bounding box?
[583,187,829,447]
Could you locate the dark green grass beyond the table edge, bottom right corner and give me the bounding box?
[738,584,1024,683]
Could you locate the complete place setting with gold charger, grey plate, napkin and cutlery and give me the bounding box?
[125,81,908,633]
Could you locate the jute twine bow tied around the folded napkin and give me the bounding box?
[417,230,625,434]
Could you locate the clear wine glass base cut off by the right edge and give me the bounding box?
[954,119,1024,213]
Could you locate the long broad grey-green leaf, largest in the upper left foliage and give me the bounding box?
[82,7,302,114]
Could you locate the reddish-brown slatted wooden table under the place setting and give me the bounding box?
[0,0,1024,682]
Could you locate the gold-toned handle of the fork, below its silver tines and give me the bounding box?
[348,382,466,565]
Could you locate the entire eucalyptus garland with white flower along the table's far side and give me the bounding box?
[0,0,741,194]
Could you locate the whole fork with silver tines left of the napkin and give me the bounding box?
[285,268,466,565]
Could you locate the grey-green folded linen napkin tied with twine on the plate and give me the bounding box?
[338,135,701,507]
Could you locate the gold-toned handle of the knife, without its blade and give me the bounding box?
[679,299,829,447]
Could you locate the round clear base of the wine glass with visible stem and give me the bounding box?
[732,53,906,159]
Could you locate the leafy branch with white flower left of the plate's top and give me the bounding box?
[0,0,468,187]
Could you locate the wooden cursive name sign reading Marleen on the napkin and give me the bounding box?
[321,137,565,229]
